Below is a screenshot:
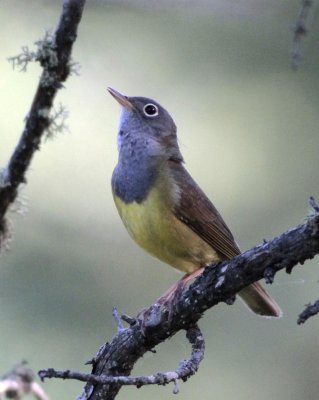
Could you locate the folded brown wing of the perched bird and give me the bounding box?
[169,161,240,259]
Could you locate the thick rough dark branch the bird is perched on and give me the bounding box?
[41,203,319,400]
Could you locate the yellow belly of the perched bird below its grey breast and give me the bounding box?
[113,186,220,273]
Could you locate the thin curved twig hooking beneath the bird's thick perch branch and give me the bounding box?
[39,325,205,394]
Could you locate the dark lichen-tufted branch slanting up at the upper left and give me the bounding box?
[0,0,85,249]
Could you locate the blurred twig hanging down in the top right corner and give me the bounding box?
[290,0,313,70]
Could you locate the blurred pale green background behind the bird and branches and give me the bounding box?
[0,0,319,400]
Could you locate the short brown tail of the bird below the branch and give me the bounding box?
[239,282,282,318]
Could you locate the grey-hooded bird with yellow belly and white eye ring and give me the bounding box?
[107,87,282,317]
